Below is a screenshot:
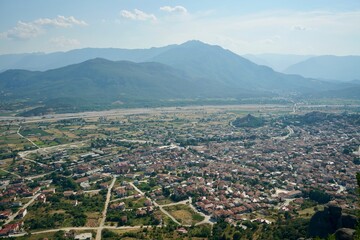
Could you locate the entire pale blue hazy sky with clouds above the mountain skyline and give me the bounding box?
[0,0,360,55]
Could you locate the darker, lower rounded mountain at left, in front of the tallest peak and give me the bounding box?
[0,58,197,102]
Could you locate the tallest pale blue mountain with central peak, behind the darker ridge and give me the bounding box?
[150,41,329,93]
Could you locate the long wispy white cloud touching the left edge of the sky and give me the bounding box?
[0,16,87,40]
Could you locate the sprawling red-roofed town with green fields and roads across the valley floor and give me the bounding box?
[0,105,360,239]
